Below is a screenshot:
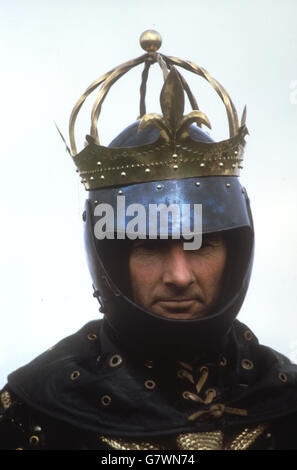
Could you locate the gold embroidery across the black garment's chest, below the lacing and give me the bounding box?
[100,424,267,450]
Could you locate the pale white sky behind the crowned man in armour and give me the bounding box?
[0,0,297,386]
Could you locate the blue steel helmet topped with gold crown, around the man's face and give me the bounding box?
[63,31,254,357]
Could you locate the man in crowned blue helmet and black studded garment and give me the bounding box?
[0,31,297,450]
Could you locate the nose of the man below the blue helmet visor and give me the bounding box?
[163,243,195,289]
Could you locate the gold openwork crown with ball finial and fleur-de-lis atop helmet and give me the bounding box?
[59,30,248,190]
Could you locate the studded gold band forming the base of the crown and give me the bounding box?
[73,127,247,190]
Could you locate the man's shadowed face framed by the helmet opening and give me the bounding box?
[129,235,227,320]
